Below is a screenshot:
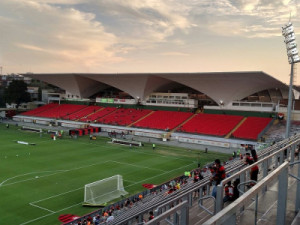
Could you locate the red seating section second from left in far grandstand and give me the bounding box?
[35,104,87,119]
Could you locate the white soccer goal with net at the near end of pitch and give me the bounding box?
[84,175,128,206]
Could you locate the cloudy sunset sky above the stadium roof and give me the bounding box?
[0,0,300,85]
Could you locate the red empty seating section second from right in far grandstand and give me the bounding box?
[177,114,244,136]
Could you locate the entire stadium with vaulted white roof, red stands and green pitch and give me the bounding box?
[0,71,300,225]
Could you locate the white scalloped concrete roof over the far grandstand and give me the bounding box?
[23,71,288,105]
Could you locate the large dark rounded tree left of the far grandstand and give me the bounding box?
[4,80,30,108]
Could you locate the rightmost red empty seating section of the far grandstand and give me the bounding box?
[232,117,272,140]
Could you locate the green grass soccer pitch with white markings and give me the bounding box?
[0,124,228,225]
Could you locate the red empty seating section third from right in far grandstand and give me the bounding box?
[133,111,193,130]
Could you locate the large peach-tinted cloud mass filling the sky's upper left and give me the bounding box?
[0,0,122,72]
